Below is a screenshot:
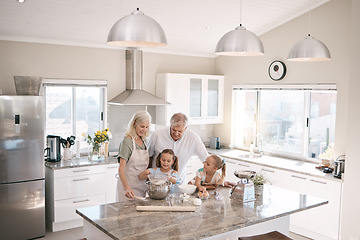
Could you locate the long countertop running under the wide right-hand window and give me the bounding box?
[207,148,342,182]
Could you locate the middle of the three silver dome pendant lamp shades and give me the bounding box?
[215,24,264,56]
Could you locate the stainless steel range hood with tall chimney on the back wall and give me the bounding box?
[108,49,170,105]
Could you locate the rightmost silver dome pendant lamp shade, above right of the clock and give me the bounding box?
[288,34,331,62]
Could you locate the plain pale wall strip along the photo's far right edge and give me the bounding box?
[341,0,360,240]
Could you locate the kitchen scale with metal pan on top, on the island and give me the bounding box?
[230,170,256,202]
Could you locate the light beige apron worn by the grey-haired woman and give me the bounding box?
[116,138,149,202]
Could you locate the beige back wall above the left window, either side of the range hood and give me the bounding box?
[0,41,215,100]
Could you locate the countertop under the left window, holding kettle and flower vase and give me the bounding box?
[45,156,118,170]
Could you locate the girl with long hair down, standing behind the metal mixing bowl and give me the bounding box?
[139,149,179,184]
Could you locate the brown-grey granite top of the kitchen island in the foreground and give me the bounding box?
[76,185,328,240]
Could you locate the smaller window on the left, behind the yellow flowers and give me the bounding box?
[44,79,106,151]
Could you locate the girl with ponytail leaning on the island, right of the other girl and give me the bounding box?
[195,154,226,196]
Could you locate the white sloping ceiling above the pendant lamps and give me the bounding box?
[0,0,329,56]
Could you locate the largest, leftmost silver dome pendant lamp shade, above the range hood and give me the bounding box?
[107,9,167,48]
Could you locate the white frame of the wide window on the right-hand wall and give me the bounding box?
[230,84,337,162]
